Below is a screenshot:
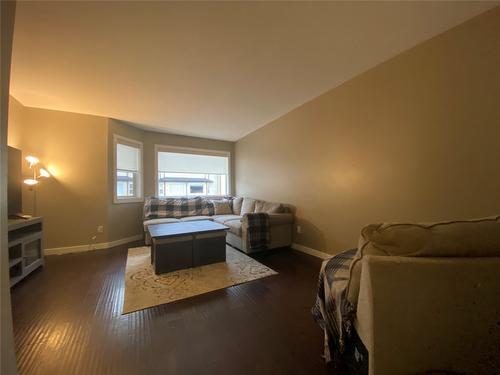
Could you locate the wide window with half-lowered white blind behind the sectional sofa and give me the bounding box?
[156,146,229,197]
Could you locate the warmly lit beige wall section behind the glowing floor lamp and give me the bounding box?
[8,97,108,248]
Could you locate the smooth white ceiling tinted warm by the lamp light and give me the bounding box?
[11,1,498,141]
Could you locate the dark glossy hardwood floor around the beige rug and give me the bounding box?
[12,246,327,375]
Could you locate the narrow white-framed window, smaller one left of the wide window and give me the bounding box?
[114,135,142,203]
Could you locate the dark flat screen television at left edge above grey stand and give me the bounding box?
[7,146,23,216]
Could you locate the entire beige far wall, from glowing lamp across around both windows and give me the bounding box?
[8,105,234,248]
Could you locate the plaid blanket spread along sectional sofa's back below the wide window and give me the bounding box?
[144,197,215,219]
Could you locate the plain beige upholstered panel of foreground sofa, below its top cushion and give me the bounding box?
[355,256,500,374]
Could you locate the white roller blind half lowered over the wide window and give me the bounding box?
[158,151,228,174]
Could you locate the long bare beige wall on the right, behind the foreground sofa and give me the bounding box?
[235,7,500,253]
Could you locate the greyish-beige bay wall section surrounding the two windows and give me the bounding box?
[108,119,234,241]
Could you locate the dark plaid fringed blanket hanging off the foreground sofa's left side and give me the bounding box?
[312,249,357,363]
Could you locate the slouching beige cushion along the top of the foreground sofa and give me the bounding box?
[348,216,500,304]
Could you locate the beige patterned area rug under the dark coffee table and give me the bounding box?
[123,246,278,314]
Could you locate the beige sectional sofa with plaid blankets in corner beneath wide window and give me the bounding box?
[143,197,294,253]
